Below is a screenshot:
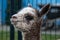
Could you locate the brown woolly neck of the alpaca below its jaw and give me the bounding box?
[22,29,40,40]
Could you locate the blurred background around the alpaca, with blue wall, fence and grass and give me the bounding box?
[0,0,60,40]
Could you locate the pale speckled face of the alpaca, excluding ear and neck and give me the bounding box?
[11,7,38,31]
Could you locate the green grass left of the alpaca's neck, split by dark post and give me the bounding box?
[0,31,18,40]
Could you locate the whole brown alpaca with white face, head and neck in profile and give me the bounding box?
[10,4,51,40]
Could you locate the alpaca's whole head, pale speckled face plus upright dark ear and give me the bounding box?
[11,4,50,32]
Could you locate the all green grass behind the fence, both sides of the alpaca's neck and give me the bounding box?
[0,31,60,40]
